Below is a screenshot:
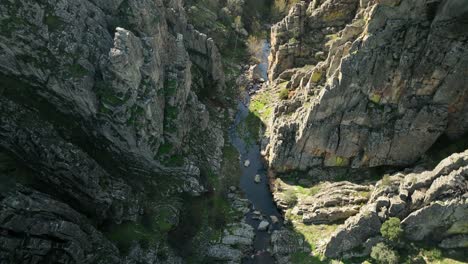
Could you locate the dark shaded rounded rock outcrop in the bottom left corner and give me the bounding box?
[0,187,121,264]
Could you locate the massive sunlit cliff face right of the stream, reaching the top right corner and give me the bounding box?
[265,0,468,177]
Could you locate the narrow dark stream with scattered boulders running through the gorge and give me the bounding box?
[229,41,282,263]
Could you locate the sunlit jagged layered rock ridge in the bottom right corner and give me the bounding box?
[324,151,468,258]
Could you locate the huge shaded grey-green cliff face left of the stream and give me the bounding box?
[0,0,225,263]
